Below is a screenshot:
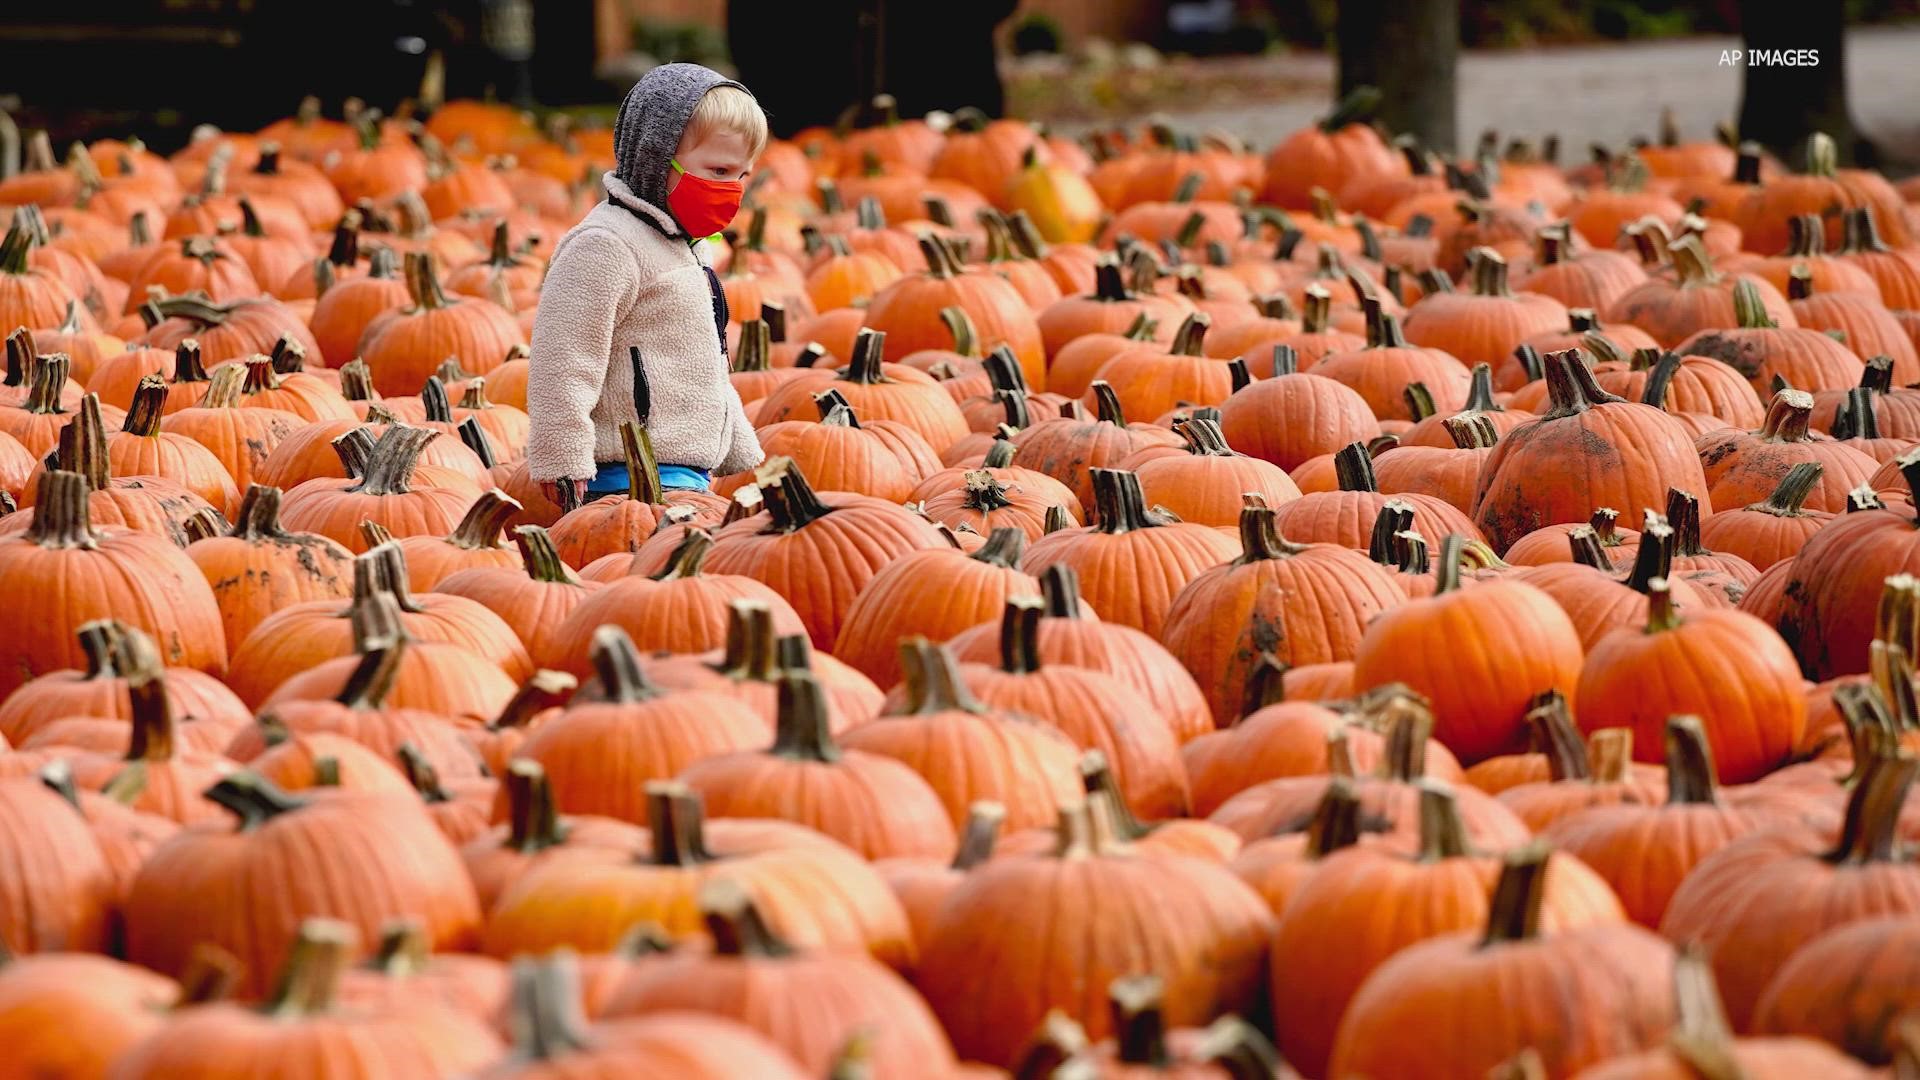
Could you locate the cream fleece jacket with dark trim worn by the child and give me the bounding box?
[526,173,764,480]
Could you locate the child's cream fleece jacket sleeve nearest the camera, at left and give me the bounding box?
[526,229,637,480]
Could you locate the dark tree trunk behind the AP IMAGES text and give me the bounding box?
[1740,0,1876,165]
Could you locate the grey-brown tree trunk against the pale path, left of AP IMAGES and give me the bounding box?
[1334,0,1459,154]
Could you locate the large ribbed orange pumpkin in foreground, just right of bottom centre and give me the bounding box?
[916,834,1273,1067]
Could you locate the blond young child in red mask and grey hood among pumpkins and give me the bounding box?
[526,63,766,505]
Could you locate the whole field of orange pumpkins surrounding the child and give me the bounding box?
[11,85,1920,1080]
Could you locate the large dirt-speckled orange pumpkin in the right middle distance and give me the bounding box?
[1473,354,1709,552]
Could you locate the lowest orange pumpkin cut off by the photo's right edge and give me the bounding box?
[1753,915,1920,1065]
